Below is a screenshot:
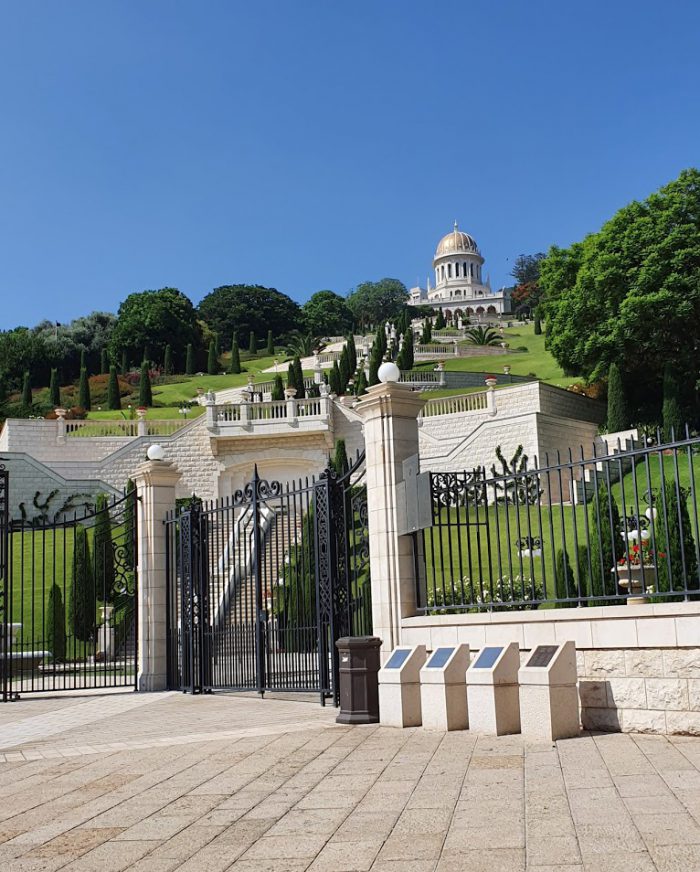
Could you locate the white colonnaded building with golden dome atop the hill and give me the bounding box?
[409,221,510,321]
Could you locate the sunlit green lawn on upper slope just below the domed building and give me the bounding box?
[416,324,580,387]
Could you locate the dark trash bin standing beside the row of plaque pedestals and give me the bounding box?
[335,636,382,724]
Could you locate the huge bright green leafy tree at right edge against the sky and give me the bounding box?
[540,169,700,418]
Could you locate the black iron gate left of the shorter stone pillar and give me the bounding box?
[0,469,137,702]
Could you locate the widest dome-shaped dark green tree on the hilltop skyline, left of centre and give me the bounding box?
[198,285,302,347]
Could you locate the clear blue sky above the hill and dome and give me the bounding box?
[0,0,700,329]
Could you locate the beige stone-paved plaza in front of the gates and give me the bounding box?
[0,693,700,872]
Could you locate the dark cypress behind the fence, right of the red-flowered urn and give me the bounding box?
[652,480,700,591]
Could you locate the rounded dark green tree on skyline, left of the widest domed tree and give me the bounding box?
[110,288,202,363]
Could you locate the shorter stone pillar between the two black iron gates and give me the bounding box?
[134,460,180,690]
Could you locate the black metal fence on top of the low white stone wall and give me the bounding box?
[416,433,700,614]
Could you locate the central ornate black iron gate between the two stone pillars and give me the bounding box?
[166,456,371,702]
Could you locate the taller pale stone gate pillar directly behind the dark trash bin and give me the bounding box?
[355,382,425,661]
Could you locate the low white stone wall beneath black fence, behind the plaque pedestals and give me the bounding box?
[401,603,700,735]
